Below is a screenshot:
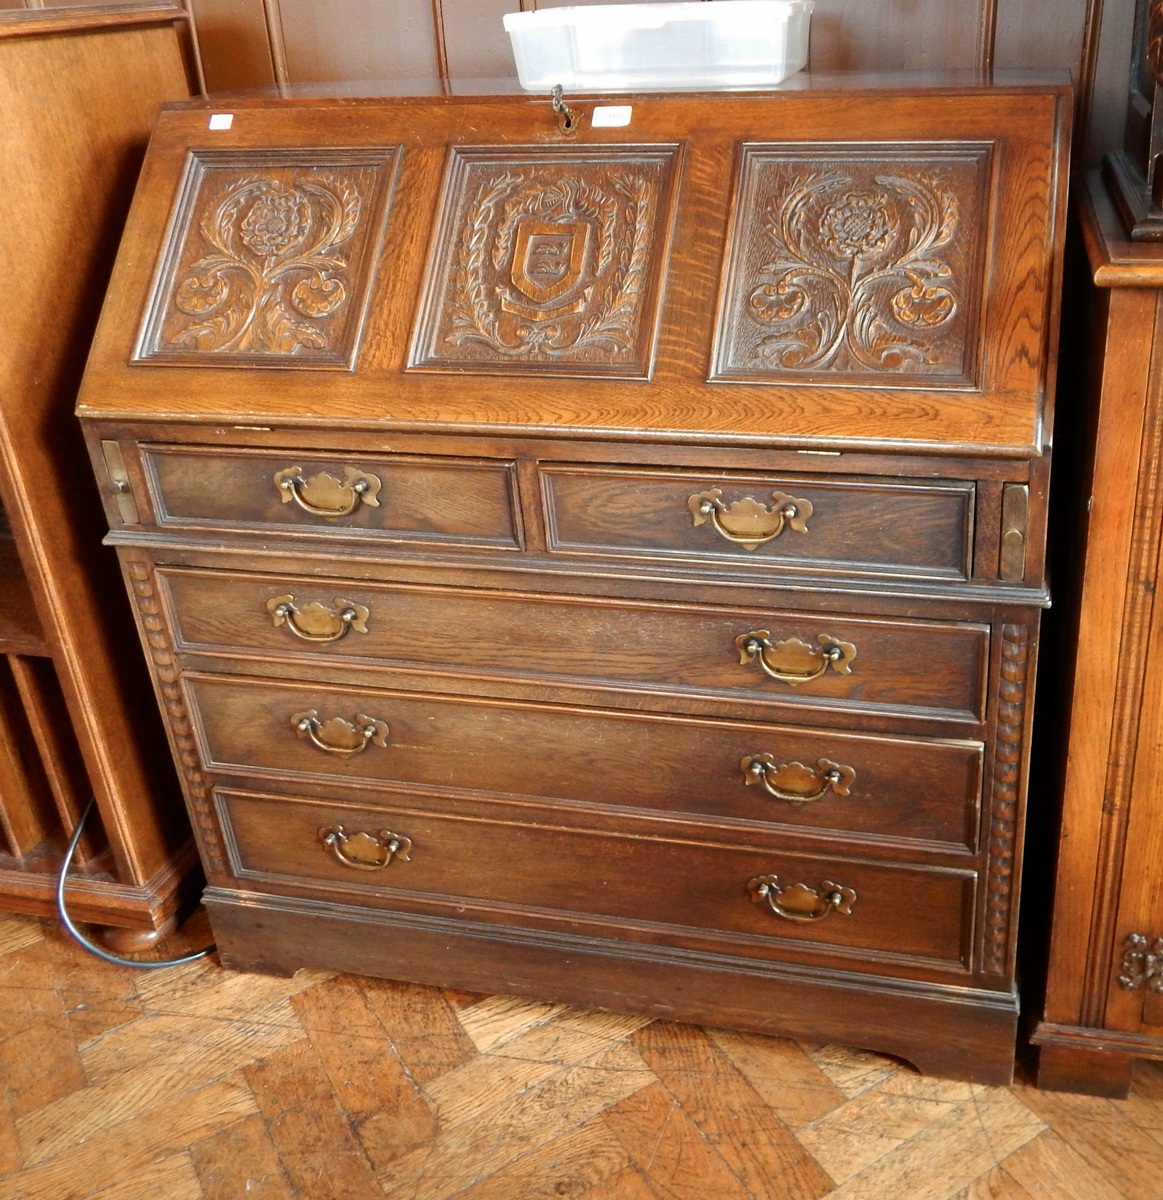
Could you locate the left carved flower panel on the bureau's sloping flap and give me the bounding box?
[134,148,398,367]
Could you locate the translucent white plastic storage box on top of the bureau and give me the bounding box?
[503,0,813,91]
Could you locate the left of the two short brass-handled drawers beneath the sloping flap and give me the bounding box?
[142,445,521,550]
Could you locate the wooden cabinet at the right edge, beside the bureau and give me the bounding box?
[1035,175,1163,1096]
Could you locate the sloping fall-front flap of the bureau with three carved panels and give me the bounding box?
[72,78,1069,455]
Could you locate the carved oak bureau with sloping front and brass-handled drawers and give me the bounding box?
[79,77,1069,1081]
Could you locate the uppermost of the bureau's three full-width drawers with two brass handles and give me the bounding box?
[157,568,989,721]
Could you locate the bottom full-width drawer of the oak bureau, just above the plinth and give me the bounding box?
[216,790,976,970]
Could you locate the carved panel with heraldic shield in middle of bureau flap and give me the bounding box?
[409,146,678,378]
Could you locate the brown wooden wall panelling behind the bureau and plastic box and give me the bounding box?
[175,0,1118,163]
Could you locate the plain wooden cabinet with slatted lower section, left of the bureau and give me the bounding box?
[0,5,197,947]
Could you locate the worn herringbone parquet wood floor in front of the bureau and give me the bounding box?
[0,914,1163,1200]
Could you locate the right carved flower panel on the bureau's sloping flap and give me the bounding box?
[711,143,990,388]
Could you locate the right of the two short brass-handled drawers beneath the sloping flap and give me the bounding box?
[541,466,975,580]
